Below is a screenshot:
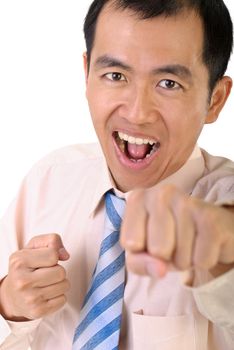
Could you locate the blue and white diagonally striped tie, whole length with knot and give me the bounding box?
[72,192,125,350]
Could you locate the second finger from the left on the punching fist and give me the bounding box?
[147,186,175,261]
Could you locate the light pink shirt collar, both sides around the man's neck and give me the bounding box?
[90,145,205,215]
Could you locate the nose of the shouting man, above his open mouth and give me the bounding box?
[120,84,158,125]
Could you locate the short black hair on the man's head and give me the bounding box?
[84,0,233,92]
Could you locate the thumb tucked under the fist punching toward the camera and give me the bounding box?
[126,252,168,278]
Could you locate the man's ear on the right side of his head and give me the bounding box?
[205,76,232,124]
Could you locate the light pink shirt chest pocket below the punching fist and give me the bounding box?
[132,313,197,350]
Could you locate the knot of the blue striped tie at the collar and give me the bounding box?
[105,192,125,231]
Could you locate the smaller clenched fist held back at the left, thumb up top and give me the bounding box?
[0,234,69,321]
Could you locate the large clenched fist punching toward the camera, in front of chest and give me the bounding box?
[121,185,234,277]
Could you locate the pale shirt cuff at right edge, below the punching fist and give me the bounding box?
[192,269,234,334]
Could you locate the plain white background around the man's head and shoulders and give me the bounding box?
[0,0,234,216]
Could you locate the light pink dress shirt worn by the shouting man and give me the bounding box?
[0,144,234,350]
